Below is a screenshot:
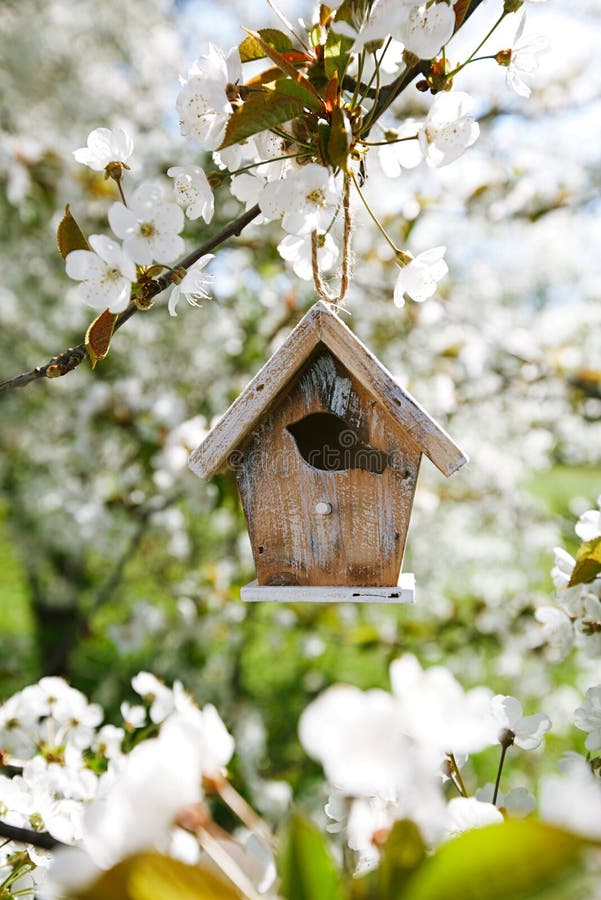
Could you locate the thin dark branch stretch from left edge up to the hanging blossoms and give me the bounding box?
[0,205,260,394]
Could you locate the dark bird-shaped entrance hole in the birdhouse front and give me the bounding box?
[286,412,389,475]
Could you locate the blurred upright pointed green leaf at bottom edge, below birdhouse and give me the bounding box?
[279,815,344,900]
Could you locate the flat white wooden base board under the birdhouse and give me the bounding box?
[240,572,415,603]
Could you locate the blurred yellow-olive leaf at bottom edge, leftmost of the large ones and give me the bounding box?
[77,853,240,900]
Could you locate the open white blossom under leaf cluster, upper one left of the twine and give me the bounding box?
[259,163,339,234]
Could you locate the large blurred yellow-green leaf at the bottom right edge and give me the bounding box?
[398,819,587,900]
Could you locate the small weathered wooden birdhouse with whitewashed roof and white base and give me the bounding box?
[190,301,467,603]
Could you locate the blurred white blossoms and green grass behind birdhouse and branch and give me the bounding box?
[0,0,601,816]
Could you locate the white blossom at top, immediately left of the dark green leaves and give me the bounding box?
[176,44,242,150]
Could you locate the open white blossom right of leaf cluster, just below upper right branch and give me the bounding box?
[419,92,480,167]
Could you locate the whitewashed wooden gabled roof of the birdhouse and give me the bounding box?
[190,300,467,478]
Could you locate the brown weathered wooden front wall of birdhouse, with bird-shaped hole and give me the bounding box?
[231,344,421,586]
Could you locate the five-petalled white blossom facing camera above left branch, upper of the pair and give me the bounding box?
[109,183,184,266]
